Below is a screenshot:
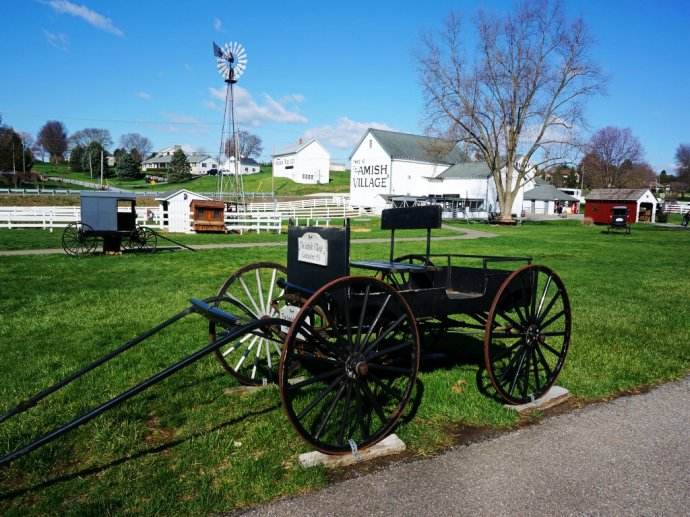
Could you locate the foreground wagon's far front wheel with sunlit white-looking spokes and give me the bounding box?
[209,262,294,385]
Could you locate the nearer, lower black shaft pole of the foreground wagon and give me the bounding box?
[0,316,284,467]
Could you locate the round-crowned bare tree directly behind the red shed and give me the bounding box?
[587,126,644,188]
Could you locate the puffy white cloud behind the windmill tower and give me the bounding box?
[204,86,308,127]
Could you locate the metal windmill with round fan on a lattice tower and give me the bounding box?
[213,41,247,203]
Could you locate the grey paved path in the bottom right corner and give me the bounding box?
[241,377,690,516]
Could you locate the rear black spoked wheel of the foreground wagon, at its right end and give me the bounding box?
[484,265,571,404]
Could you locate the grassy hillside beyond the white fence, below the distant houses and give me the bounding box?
[34,163,350,196]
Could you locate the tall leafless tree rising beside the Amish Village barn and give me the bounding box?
[419,0,603,221]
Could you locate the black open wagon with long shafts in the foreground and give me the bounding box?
[0,206,571,465]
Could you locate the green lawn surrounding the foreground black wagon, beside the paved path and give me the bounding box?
[0,221,690,515]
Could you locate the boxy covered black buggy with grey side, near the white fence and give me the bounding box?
[62,191,157,256]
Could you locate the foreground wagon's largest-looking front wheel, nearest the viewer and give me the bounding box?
[278,276,420,454]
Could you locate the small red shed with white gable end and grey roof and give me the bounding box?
[585,188,657,224]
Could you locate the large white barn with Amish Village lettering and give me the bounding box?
[350,129,523,217]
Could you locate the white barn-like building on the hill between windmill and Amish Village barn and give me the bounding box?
[273,139,331,183]
